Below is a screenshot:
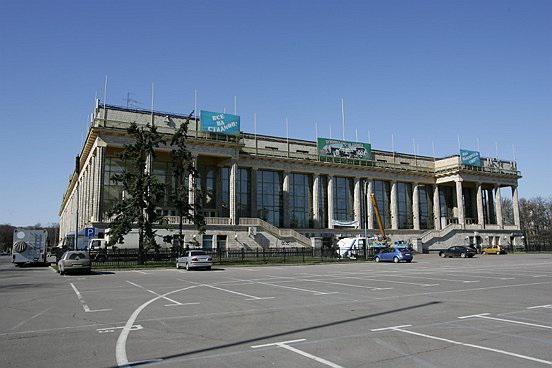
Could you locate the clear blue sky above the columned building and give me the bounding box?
[0,0,552,225]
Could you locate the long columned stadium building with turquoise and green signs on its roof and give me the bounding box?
[59,102,523,250]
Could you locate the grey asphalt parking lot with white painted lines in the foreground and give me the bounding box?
[0,254,552,368]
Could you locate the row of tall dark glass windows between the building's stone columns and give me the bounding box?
[102,157,442,229]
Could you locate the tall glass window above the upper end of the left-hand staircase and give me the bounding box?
[257,170,283,226]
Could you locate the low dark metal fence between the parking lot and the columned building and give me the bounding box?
[90,248,374,268]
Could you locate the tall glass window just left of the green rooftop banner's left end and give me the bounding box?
[289,173,312,228]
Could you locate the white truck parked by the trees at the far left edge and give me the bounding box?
[12,228,55,266]
